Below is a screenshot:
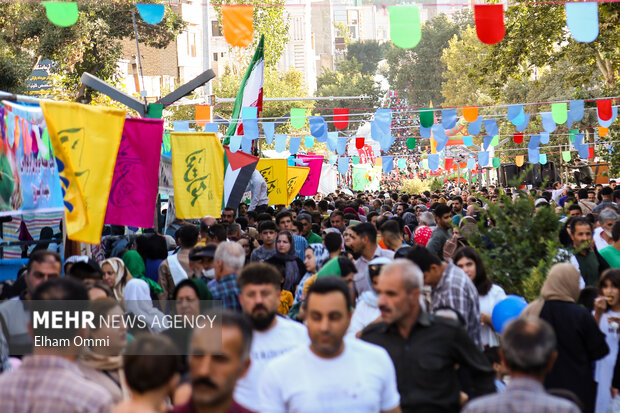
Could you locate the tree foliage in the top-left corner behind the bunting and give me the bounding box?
[0,0,185,102]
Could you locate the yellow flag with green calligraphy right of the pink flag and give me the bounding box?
[170,132,224,219]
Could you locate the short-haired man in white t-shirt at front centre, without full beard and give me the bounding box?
[258,277,401,413]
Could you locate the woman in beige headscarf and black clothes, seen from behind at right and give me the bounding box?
[521,263,609,413]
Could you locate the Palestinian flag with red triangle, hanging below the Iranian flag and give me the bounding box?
[223,146,259,210]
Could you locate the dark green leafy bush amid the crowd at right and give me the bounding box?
[466,182,561,299]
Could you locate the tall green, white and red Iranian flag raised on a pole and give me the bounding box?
[224,35,265,138]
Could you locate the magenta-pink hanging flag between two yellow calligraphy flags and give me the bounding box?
[105,118,164,228]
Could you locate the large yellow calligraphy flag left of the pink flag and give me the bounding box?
[41,101,125,244]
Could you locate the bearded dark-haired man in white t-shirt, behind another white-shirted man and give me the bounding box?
[235,262,310,410]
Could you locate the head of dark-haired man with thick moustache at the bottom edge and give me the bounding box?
[171,310,252,413]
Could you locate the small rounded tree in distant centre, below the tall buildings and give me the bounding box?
[316,57,382,108]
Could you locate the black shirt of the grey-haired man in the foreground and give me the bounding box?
[361,311,495,413]
